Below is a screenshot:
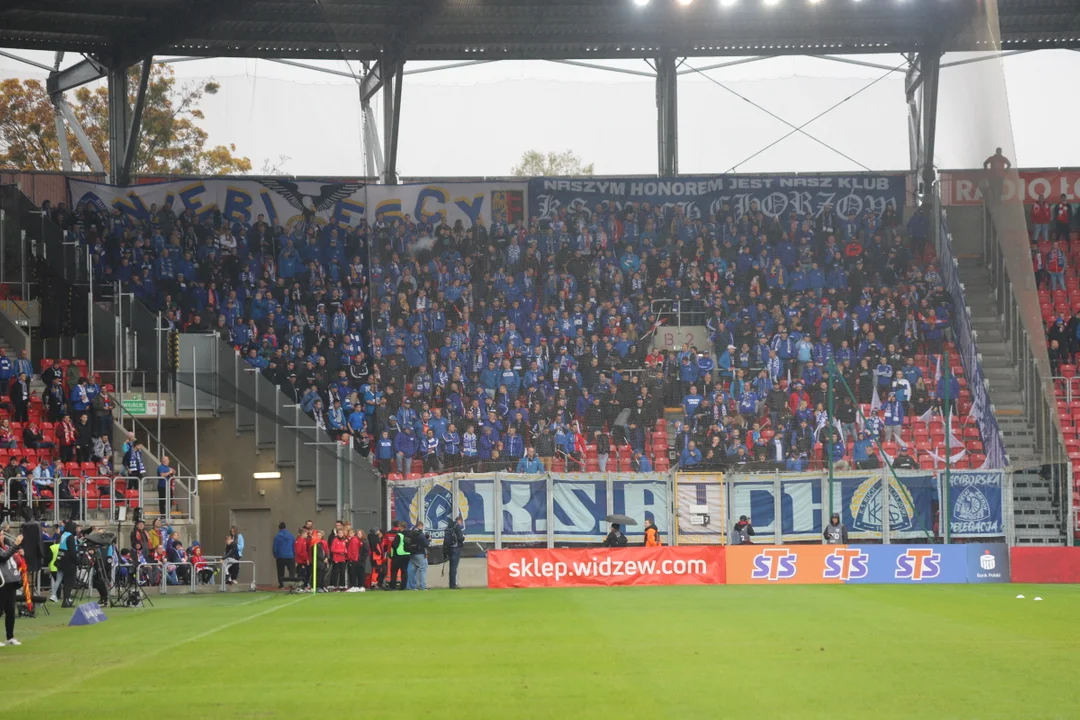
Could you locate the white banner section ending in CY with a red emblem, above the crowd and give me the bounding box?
[367,182,528,228]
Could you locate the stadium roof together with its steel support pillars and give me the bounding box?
[0,0,1080,193]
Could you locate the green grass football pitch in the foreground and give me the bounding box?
[0,585,1080,720]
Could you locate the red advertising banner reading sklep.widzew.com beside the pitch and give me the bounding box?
[487,546,727,587]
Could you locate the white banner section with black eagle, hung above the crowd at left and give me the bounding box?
[68,178,367,232]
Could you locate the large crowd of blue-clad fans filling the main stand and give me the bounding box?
[44,185,981,477]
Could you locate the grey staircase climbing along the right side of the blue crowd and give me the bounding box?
[958,256,1062,545]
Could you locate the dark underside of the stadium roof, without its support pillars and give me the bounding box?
[0,0,1080,64]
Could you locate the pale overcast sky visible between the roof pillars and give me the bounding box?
[0,50,1080,177]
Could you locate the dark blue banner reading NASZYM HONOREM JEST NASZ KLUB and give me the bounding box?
[528,175,907,221]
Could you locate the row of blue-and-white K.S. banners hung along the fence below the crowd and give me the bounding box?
[386,468,1015,548]
